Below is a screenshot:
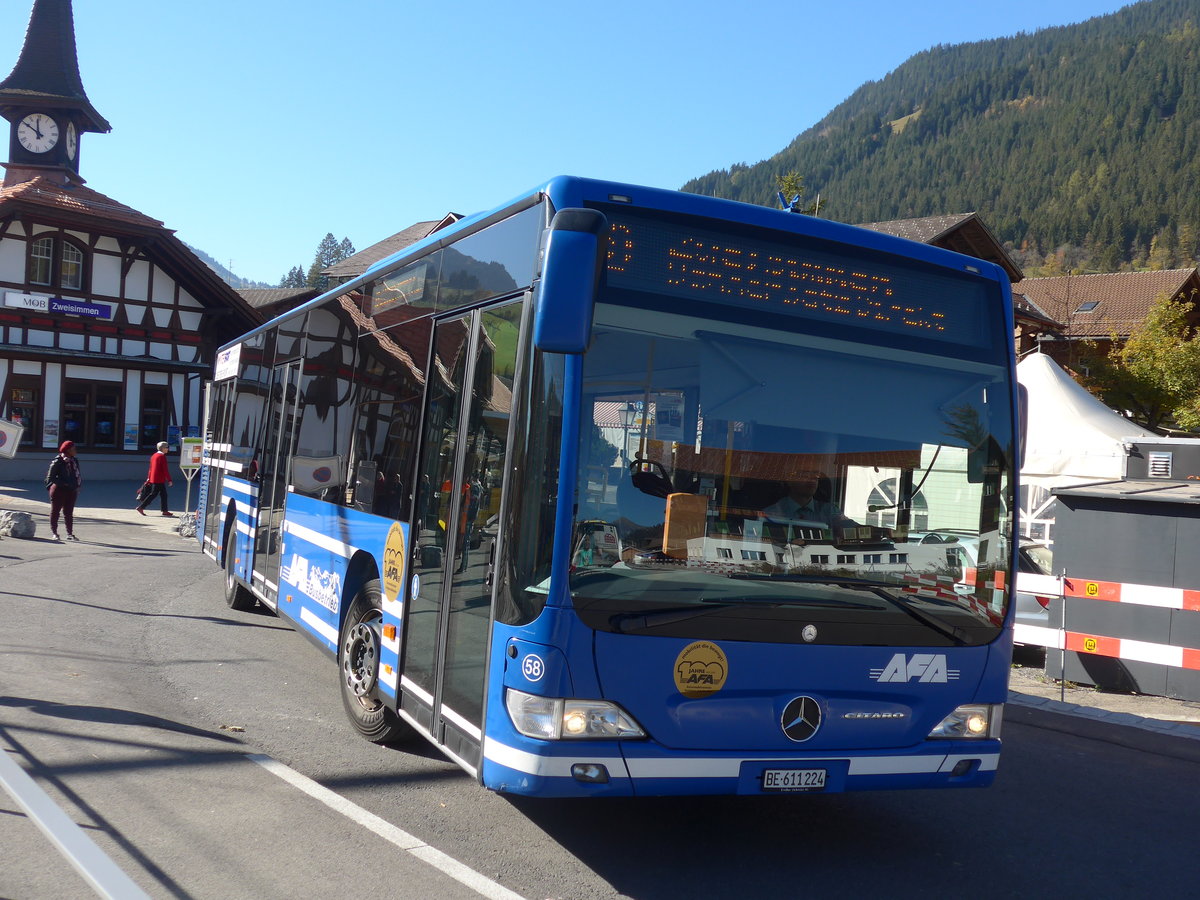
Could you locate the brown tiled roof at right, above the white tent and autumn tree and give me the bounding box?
[1013,269,1200,337]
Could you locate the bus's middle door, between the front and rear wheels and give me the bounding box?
[254,360,300,607]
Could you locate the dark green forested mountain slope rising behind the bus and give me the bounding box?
[683,0,1200,274]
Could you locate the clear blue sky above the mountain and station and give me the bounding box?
[0,0,1126,284]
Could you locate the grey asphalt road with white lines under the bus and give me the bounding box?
[0,486,1200,900]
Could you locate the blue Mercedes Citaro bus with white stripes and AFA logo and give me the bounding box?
[197,176,1020,797]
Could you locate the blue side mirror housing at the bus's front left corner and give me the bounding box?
[533,209,608,353]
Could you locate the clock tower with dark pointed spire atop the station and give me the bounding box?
[0,0,112,184]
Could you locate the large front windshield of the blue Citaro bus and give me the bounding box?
[570,230,1013,647]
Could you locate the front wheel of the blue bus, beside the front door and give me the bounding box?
[337,578,416,744]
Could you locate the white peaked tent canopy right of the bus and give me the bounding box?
[1016,353,1156,490]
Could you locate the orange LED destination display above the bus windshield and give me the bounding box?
[607,216,986,346]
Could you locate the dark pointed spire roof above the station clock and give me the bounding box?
[0,0,112,132]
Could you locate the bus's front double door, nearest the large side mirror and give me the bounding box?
[401,302,522,772]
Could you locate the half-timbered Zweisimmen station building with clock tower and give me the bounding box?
[0,0,262,480]
